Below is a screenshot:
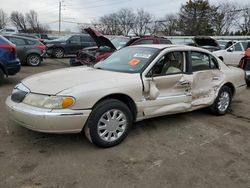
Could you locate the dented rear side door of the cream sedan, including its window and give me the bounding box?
[190,51,223,107]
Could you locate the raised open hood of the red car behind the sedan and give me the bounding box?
[84,27,116,50]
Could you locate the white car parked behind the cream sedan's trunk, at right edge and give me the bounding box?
[213,41,250,66]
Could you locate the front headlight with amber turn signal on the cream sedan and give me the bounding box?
[23,93,75,109]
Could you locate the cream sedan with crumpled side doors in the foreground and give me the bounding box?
[6,45,246,147]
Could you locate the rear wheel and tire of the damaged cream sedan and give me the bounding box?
[210,86,232,115]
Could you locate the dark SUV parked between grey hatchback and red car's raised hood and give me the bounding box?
[46,34,96,58]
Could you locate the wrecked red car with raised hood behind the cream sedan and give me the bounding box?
[70,28,172,66]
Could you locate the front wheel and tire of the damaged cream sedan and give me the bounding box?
[84,99,132,148]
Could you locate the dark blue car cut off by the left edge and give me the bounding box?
[0,35,21,80]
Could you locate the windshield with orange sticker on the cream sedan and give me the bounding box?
[95,47,159,73]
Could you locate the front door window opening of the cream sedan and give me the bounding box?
[149,52,185,76]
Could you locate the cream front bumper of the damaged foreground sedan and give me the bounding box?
[6,96,91,133]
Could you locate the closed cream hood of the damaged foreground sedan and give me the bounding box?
[22,67,135,95]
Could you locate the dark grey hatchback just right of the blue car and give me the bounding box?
[4,35,45,66]
